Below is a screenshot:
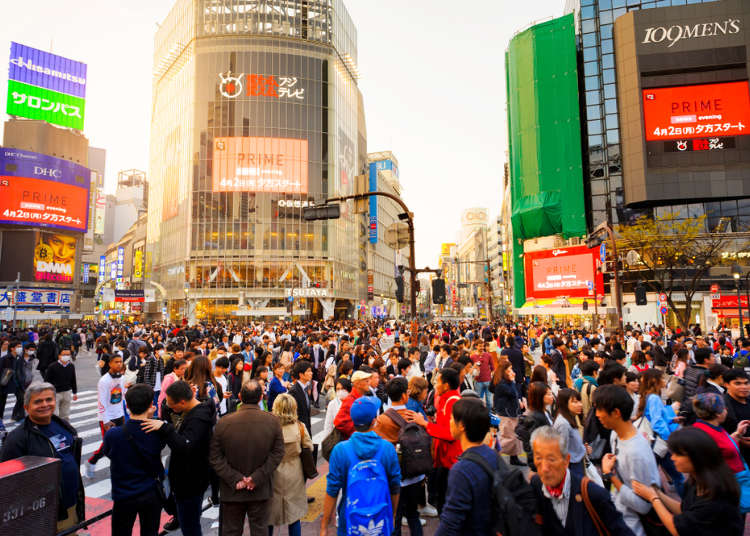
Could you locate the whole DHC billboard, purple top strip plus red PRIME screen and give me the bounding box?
[0,148,91,232]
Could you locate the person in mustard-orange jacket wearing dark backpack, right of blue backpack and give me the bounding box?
[374,378,432,536]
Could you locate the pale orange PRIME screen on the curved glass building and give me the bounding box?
[212,137,308,194]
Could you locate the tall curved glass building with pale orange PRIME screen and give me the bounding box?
[146,0,367,320]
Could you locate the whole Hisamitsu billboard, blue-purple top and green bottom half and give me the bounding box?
[6,42,86,130]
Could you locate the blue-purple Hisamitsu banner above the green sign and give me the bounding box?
[8,42,86,99]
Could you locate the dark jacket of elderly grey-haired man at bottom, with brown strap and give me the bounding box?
[531,474,633,536]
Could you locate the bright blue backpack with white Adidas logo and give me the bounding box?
[344,448,400,536]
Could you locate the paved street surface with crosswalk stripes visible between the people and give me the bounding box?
[3,351,437,536]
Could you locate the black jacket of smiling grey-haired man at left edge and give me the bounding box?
[0,415,86,520]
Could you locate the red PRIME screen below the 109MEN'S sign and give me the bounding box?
[643,82,750,141]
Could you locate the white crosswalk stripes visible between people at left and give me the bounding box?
[3,390,325,529]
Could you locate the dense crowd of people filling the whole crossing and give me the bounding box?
[0,321,750,536]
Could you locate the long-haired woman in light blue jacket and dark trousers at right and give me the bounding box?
[636,369,685,496]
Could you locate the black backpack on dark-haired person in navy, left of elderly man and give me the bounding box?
[459,451,541,536]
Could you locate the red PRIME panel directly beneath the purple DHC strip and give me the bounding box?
[0,175,89,232]
